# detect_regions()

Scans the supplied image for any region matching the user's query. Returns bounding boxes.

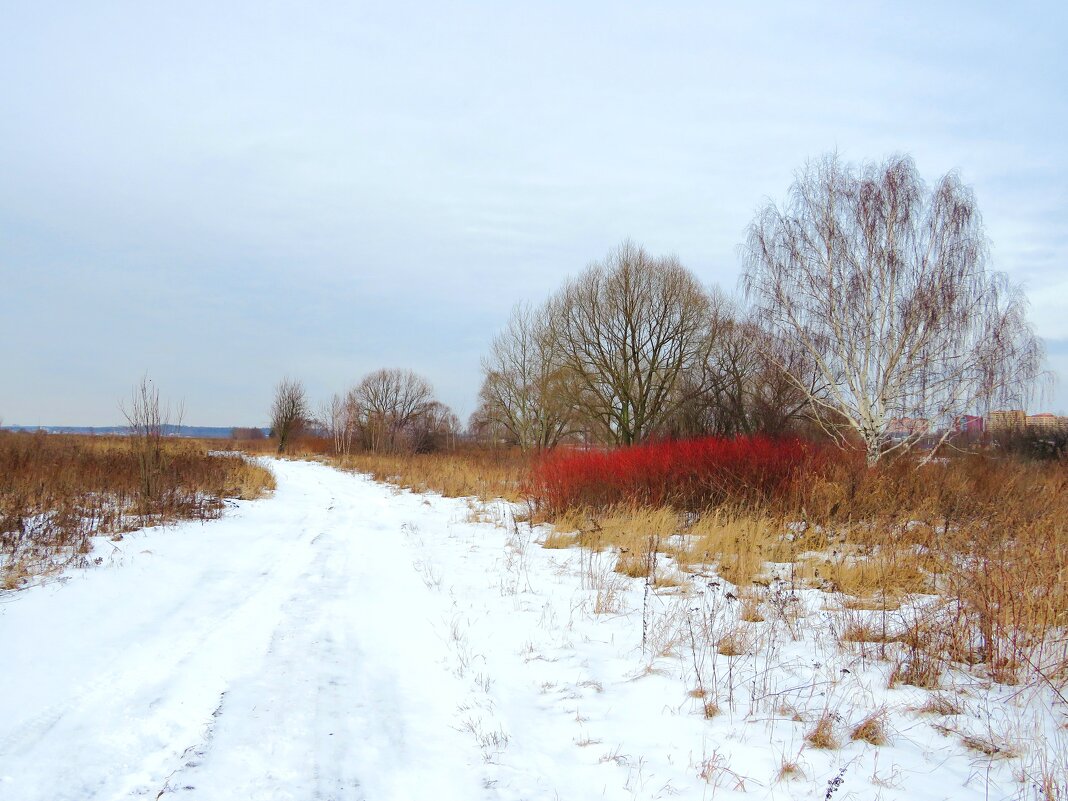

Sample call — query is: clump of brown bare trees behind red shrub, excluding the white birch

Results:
[470,241,815,450]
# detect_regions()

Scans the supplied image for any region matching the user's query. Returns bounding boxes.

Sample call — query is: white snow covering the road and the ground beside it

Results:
[0,461,1068,801]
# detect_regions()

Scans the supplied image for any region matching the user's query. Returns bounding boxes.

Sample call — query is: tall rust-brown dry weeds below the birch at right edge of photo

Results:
[811,457,1068,690]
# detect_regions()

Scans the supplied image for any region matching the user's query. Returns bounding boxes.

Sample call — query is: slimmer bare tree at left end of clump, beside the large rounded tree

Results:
[476,304,572,451]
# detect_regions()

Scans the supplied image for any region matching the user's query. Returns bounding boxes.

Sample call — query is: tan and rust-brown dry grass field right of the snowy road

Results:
[534,448,1068,693]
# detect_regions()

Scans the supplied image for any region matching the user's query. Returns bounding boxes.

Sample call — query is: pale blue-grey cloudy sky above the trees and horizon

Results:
[0,0,1068,425]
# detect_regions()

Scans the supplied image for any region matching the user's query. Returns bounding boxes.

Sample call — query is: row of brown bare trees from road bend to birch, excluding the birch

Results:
[271,241,811,455]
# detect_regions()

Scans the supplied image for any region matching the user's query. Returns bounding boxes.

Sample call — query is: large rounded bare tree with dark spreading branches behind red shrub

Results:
[551,241,720,444]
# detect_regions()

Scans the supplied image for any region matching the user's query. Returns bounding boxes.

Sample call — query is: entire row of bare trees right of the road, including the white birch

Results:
[272,154,1042,466]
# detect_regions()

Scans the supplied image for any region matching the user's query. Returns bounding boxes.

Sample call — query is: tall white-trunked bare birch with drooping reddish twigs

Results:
[743,155,1042,465]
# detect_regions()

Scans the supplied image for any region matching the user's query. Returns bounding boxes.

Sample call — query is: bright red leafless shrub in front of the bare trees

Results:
[530,436,827,514]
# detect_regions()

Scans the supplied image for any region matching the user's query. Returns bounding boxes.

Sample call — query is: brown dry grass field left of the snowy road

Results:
[0,431,274,590]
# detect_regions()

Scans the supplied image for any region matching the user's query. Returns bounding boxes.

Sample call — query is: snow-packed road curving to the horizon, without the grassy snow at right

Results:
[0,461,485,801]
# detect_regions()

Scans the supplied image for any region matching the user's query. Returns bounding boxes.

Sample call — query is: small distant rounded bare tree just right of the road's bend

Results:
[351,370,437,452]
